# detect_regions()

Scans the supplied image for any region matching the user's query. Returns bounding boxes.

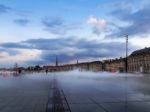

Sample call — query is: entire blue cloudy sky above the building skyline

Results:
[0,0,150,68]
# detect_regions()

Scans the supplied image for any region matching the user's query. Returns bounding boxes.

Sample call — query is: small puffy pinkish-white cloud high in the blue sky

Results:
[87,16,106,35]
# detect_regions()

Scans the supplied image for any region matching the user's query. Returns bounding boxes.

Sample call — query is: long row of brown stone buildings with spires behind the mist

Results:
[26,48,150,73]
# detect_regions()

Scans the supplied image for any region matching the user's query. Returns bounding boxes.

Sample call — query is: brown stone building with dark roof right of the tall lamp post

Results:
[128,48,150,73]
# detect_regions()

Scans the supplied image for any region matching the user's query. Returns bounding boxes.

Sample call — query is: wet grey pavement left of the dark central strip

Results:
[0,74,51,112]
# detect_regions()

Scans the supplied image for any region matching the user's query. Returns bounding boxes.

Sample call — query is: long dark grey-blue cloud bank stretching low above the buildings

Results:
[0,37,134,64]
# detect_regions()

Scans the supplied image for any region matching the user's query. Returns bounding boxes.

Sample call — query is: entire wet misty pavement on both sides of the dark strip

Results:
[0,71,150,112]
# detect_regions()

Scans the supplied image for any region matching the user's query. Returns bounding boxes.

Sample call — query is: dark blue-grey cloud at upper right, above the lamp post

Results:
[109,5,150,37]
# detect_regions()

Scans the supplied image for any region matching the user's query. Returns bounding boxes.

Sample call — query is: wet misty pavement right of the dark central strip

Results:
[56,71,150,112]
